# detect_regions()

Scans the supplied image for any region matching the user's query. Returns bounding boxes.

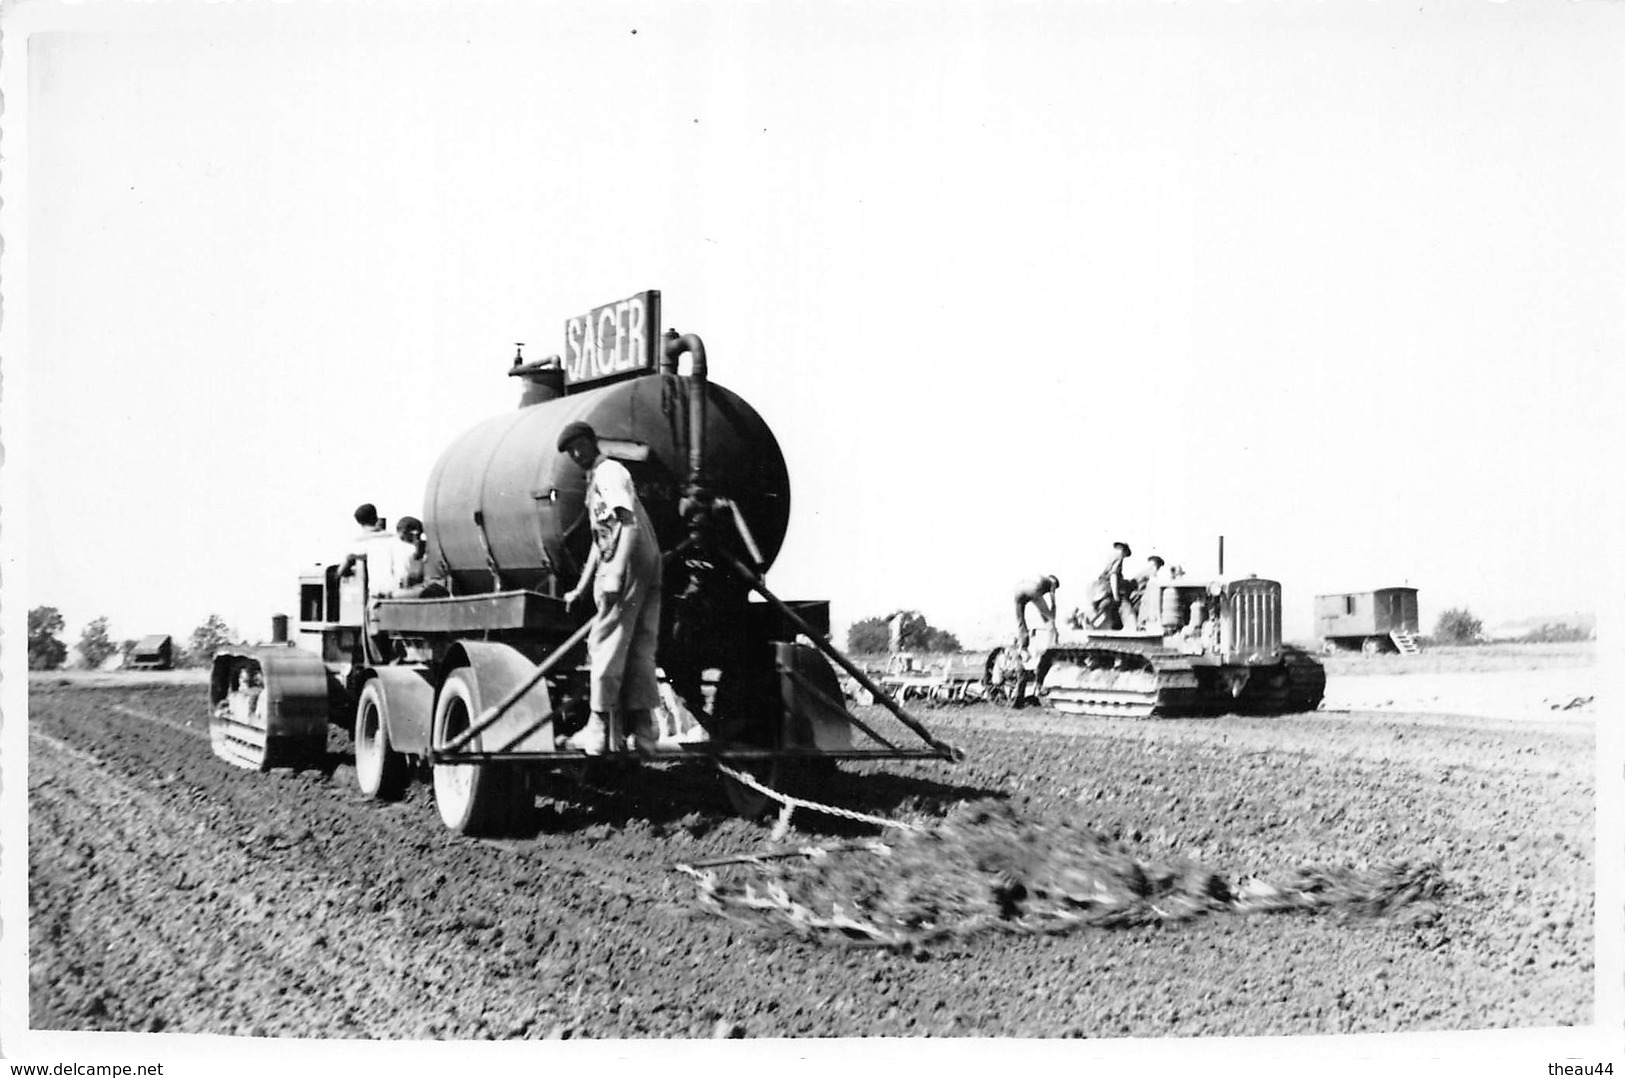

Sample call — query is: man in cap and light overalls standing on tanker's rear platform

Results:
[559,421,661,756]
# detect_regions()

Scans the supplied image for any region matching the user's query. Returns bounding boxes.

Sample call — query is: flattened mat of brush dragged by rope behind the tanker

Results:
[674,802,1450,951]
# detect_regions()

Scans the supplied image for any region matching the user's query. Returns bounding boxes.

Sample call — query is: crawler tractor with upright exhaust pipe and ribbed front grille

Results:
[985,538,1326,719]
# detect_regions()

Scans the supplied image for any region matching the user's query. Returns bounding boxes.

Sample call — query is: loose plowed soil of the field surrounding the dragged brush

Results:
[28,680,1594,1037]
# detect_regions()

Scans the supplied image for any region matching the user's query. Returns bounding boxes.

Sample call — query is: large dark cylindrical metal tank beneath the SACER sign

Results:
[423,374,790,595]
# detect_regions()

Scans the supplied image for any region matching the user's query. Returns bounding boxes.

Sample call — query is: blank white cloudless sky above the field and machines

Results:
[0,2,1625,644]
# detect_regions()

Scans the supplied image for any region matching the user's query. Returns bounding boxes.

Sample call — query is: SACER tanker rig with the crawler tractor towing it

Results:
[210,291,959,834]
